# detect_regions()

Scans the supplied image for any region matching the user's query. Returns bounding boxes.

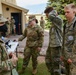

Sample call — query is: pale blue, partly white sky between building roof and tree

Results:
[16,0,48,14]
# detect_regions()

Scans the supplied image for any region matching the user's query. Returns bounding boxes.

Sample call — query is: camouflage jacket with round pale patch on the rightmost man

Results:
[64,17,76,59]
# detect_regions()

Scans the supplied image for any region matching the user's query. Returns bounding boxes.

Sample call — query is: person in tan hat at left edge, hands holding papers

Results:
[0,15,18,75]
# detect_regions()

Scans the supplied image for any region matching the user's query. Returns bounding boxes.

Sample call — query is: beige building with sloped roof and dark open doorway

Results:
[0,0,28,34]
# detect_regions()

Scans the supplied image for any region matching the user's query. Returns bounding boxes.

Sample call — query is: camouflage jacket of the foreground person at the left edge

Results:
[0,39,11,75]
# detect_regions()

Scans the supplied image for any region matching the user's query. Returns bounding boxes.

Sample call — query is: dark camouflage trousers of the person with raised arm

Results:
[45,46,61,75]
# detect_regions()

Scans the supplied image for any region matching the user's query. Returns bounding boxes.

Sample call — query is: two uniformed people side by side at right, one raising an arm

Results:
[44,4,76,75]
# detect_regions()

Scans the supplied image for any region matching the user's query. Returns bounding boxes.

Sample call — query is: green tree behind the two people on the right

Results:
[47,0,76,16]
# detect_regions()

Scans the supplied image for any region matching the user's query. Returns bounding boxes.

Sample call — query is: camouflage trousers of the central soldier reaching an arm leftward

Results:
[23,47,39,69]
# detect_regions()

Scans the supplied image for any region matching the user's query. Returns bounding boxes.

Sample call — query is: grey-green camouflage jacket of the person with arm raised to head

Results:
[49,11,63,47]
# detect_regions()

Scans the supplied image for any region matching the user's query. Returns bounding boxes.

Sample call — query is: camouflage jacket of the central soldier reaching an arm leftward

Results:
[19,25,44,47]
